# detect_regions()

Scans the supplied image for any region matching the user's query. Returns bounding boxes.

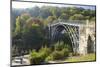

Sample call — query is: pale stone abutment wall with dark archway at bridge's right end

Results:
[79,21,95,55]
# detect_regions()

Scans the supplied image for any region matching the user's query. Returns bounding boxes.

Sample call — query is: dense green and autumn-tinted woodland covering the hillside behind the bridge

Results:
[11,6,95,55]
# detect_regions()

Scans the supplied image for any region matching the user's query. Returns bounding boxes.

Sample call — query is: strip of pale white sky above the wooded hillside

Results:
[12,1,95,10]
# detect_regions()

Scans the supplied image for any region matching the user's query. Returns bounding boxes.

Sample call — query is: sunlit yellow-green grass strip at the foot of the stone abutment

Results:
[65,53,96,62]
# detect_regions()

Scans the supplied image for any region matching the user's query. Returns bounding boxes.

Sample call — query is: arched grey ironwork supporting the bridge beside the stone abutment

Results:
[49,23,79,52]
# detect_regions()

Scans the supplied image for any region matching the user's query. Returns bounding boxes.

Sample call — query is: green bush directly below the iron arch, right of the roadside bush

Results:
[45,42,70,61]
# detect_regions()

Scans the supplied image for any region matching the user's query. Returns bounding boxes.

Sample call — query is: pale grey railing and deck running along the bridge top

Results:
[48,19,95,27]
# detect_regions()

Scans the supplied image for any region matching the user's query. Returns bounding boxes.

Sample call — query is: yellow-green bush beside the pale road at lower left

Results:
[30,46,51,64]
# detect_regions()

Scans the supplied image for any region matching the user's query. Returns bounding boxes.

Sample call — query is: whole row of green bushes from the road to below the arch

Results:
[30,42,70,64]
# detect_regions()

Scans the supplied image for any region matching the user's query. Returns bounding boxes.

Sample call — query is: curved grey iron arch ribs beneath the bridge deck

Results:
[48,24,79,53]
